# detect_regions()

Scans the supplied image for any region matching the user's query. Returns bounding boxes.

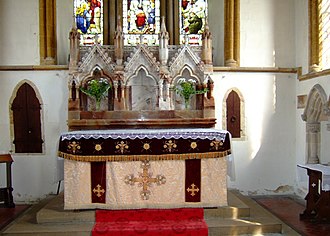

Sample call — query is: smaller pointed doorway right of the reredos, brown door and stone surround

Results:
[222,88,245,139]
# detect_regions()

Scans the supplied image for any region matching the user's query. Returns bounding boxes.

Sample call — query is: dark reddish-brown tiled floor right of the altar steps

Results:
[254,196,330,236]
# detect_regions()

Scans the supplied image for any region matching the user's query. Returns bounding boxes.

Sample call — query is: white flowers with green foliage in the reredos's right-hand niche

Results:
[174,78,208,109]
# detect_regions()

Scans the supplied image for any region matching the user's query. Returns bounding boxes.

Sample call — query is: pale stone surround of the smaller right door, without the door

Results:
[222,87,246,140]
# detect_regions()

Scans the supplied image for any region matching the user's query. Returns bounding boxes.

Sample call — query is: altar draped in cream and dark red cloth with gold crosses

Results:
[58,129,230,210]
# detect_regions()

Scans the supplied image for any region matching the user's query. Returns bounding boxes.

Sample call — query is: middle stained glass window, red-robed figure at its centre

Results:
[123,0,160,46]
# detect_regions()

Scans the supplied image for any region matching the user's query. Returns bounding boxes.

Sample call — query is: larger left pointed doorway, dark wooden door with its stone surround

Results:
[9,80,44,153]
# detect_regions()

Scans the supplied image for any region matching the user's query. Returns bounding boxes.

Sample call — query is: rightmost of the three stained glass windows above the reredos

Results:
[179,0,207,45]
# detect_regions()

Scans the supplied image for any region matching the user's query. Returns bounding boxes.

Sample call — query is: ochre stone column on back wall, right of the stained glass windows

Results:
[224,0,240,67]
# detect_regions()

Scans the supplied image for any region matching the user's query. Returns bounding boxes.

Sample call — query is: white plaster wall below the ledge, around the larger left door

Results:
[0,71,68,202]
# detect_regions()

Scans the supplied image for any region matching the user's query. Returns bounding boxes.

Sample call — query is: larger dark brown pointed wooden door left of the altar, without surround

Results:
[11,83,43,153]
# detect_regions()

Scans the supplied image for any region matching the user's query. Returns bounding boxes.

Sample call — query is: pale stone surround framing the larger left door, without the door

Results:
[9,79,45,154]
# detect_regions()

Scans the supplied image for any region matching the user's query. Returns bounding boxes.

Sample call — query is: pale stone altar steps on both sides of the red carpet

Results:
[2,191,298,236]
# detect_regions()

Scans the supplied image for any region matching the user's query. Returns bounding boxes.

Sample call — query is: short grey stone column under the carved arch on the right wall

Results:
[306,123,321,164]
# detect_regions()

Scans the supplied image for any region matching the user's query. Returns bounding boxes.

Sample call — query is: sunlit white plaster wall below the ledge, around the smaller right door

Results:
[212,72,296,194]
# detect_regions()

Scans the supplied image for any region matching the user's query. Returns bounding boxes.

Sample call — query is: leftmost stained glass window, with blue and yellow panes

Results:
[74,0,103,45]
